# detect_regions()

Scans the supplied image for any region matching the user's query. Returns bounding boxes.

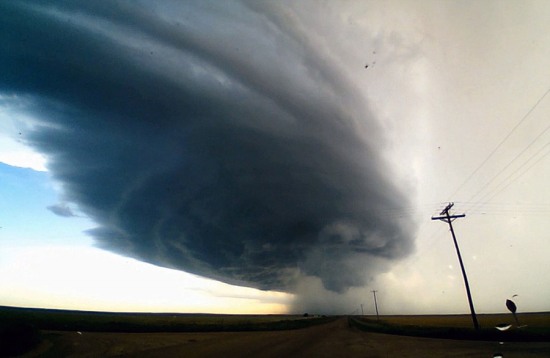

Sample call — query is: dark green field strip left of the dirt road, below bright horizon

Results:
[0,307,335,332]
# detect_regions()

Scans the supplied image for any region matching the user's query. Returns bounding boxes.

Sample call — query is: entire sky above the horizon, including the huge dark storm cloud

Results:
[0,1,550,314]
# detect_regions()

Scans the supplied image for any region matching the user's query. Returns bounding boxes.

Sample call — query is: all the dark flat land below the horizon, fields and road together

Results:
[4,308,550,358]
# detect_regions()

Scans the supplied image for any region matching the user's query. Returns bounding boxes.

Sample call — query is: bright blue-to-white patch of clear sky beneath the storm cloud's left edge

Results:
[0,162,289,313]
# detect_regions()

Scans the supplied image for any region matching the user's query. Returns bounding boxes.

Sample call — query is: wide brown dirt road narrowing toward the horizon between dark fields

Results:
[27,318,550,358]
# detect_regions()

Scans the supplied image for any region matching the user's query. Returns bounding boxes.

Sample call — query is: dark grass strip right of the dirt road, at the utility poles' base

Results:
[349,312,550,342]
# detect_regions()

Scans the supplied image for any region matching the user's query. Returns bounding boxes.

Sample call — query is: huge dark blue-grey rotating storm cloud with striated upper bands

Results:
[0,1,412,291]
